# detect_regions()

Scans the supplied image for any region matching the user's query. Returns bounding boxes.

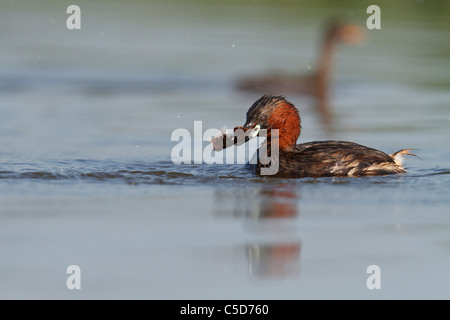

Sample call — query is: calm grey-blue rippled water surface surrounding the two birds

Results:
[0,1,450,299]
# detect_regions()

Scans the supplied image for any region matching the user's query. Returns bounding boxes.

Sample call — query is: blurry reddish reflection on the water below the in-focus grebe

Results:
[216,184,301,278]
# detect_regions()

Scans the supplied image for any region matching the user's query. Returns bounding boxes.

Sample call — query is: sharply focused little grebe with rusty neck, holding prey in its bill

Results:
[211,95,413,178]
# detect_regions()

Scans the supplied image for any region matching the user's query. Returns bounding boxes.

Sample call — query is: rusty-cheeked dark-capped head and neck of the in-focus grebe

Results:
[239,95,301,150]
